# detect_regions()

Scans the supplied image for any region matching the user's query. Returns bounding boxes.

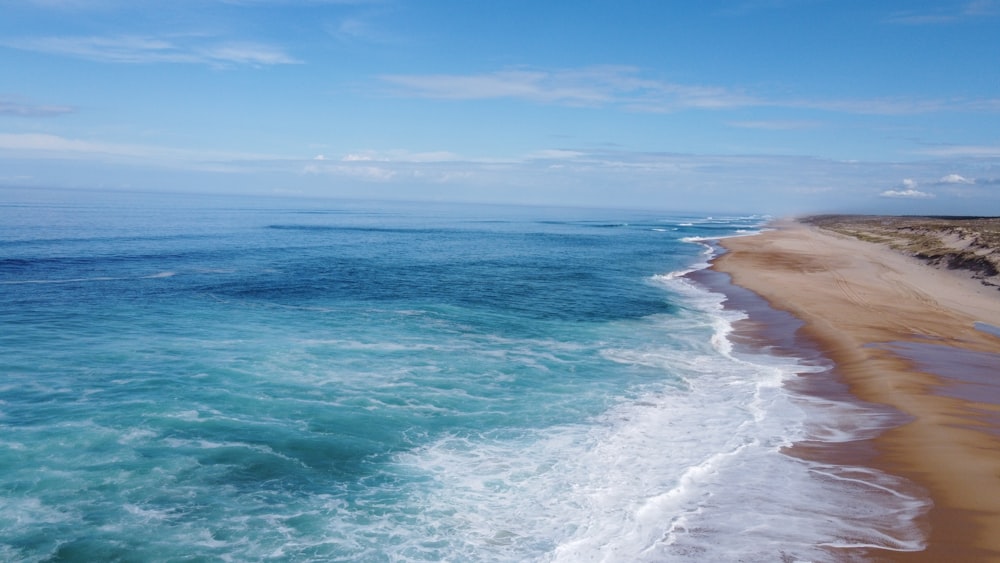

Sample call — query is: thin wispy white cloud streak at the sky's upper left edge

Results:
[0,35,299,66]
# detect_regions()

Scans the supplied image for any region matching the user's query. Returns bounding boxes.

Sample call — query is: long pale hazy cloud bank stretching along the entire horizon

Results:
[0,134,1000,215]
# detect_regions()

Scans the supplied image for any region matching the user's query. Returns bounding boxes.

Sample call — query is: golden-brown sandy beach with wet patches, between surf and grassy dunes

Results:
[713,221,1000,562]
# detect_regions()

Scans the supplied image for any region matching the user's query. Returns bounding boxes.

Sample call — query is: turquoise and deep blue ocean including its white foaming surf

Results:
[0,190,929,562]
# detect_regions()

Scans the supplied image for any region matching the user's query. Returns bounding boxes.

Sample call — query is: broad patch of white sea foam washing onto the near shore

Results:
[376,268,929,561]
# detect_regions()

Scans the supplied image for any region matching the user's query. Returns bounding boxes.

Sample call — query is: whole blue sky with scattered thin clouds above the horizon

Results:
[0,0,1000,215]
